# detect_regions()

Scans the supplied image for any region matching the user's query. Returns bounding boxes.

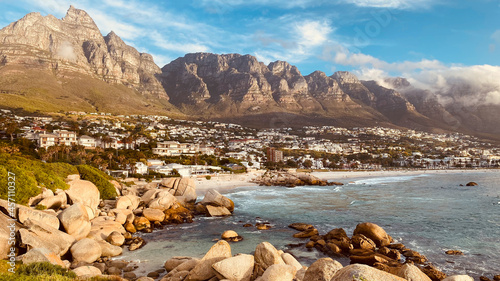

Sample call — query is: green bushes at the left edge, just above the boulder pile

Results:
[0,153,78,204]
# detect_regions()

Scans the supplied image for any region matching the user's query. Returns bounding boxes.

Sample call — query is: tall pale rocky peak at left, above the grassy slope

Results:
[0,6,168,99]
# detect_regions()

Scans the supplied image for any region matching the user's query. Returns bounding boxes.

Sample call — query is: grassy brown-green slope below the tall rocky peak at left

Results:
[0,65,184,117]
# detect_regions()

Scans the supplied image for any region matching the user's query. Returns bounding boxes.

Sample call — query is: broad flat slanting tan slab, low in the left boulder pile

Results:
[19,219,76,256]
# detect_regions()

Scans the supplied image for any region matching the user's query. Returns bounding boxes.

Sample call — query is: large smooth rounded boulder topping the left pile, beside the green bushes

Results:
[66,180,100,218]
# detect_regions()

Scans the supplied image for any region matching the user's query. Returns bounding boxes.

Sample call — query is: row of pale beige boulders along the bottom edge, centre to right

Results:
[156,237,480,281]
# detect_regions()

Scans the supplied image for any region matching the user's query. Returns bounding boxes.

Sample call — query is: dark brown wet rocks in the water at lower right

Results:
[289,222,488,281]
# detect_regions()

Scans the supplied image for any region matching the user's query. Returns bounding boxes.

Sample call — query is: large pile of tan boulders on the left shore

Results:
[0,175,234,280]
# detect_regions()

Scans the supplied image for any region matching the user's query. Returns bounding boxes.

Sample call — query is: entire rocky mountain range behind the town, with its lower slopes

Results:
[0,6,500,139]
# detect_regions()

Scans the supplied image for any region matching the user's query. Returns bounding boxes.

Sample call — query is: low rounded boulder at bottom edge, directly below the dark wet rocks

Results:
[331,264,407,281]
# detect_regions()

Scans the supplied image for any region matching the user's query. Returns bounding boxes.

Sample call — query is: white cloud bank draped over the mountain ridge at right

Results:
[323,45,500,106]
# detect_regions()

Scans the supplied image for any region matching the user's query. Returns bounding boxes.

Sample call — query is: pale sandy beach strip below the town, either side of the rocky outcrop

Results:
[195,170,500,192]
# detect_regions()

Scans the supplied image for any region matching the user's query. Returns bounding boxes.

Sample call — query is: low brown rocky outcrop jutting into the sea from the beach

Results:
[253,171,343,187]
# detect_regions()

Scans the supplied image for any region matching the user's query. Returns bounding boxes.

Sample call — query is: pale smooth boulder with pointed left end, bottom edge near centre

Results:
[212,254,254,281]
